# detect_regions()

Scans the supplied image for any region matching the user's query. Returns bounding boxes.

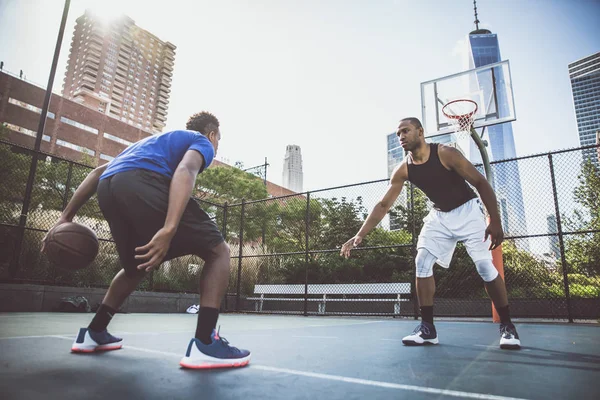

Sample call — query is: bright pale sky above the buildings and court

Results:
[0,0,600,190]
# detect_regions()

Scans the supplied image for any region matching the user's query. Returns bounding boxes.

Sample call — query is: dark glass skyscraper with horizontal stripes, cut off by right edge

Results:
[569,52,600,168]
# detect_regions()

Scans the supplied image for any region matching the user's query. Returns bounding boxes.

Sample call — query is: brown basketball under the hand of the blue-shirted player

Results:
[44,222,98,270]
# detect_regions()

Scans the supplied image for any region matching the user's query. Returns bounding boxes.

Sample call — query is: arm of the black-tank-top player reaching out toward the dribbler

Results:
[340,162,408,258]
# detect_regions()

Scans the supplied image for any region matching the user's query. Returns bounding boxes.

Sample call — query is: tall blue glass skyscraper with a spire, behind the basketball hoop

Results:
[468,8,529,244]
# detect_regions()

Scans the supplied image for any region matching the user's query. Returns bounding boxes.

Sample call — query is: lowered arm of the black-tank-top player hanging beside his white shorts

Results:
[439,146,504,250]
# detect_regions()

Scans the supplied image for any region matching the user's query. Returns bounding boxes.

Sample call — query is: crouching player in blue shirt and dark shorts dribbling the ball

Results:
[44,112,250,368]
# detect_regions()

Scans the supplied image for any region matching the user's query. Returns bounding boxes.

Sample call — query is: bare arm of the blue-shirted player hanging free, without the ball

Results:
[135,150,204,272]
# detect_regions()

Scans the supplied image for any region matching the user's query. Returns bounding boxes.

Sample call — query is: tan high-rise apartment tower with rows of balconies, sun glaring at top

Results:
[63,11,176,133]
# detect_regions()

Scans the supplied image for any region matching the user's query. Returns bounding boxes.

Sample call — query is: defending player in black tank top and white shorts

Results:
[341,118,520,349]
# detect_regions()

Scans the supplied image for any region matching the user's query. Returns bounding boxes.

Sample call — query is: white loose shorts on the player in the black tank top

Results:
[417,198,492,268]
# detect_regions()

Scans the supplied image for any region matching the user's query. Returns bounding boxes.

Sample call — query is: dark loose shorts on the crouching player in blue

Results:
[97,169,224,277]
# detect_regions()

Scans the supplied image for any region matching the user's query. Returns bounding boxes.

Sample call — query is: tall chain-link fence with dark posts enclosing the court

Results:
[0,142,600,320]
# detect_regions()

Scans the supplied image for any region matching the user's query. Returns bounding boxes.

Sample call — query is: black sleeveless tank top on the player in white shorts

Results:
[407,143,477,212]
